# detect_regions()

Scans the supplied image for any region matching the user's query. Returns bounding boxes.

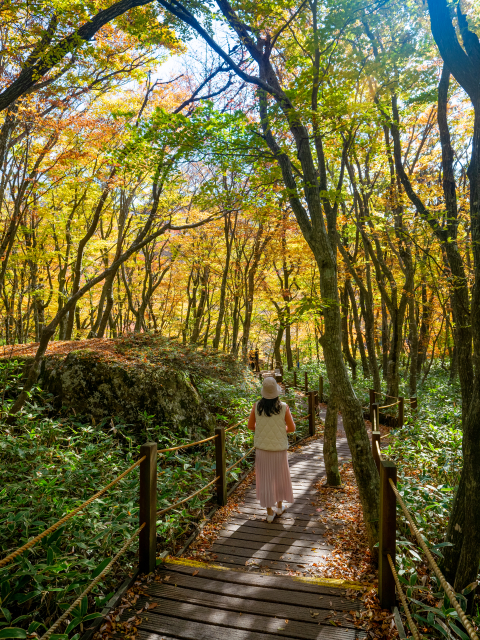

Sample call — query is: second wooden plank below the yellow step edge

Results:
[147,571,363,611]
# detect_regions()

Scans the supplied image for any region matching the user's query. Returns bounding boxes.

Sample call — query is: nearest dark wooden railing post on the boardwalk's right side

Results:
[378,460,397,609]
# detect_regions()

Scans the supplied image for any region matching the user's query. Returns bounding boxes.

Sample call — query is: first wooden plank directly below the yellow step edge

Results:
[161,563,352,597]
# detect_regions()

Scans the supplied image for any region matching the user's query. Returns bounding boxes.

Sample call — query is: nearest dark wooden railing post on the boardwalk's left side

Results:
[138,442,157,573]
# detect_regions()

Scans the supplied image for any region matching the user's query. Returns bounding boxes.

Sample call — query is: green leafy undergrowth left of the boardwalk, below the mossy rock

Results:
[0,361,258,640]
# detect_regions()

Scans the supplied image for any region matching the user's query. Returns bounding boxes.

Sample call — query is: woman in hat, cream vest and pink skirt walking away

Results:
[248,378,295,522]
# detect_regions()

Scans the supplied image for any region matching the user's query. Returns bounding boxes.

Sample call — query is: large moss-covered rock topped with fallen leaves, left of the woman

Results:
[1,334,243,438]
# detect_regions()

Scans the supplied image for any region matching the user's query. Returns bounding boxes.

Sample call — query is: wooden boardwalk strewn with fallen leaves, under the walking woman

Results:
[122,410,366,640]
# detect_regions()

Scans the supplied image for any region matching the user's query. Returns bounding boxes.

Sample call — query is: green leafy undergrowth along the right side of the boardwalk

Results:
[285,362,480,640]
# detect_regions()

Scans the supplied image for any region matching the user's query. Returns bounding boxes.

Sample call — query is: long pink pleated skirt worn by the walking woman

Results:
[255,449,294,507]
